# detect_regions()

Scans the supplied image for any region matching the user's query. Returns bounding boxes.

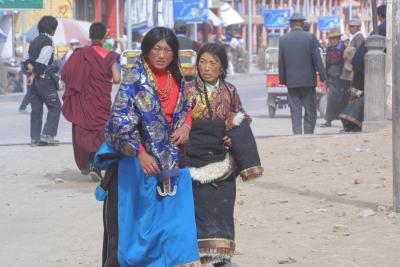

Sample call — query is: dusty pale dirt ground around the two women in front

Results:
[0,122,400,267]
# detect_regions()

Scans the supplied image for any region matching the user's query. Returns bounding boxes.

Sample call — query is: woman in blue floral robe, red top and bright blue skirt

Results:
[96,27,201,267]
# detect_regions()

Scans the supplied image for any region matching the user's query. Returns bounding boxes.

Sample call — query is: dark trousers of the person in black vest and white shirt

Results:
[30,75,61,141]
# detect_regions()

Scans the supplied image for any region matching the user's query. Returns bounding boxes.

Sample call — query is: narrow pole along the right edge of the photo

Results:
[392,1,400,213]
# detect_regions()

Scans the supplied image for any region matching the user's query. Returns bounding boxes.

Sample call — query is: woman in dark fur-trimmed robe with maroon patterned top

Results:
[185,43,263,267]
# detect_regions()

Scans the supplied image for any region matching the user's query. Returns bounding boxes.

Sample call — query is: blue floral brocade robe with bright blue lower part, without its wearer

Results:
[95,57,200,267]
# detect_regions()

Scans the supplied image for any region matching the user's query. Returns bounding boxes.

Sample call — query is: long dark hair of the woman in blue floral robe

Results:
[141,27,183,83]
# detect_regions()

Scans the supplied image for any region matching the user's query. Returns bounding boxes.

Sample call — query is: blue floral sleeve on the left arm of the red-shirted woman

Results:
[105,84,141,156]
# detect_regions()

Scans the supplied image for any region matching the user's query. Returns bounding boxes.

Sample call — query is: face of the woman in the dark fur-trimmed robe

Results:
[199,52,222,84]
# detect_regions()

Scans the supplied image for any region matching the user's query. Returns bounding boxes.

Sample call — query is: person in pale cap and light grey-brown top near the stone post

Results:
[341,19,365,81]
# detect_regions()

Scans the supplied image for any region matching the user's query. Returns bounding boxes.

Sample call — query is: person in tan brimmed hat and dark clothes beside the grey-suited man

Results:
[321,28,350,127]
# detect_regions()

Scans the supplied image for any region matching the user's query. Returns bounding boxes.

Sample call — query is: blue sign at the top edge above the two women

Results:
[174,0,208,23]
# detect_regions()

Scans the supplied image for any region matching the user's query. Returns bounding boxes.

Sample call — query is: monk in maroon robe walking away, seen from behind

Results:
[61,22,120,181]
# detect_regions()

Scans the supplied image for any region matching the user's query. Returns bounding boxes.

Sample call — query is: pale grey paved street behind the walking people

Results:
[0,72,341,145]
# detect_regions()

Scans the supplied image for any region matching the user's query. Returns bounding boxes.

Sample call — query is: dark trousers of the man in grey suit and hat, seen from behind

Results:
[288,87,317,134]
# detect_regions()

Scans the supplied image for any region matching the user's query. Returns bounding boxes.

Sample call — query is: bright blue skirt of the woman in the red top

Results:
[96,144,200,267]
